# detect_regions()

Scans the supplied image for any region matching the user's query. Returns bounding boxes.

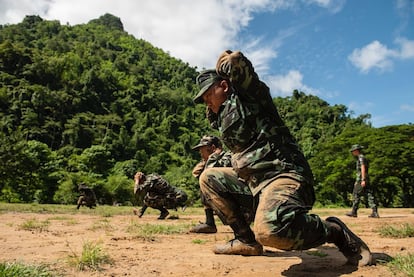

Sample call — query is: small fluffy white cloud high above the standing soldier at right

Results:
[348,38,414,73]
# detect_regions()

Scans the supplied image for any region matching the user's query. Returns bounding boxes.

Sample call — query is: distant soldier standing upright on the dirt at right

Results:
[346,144,379,218]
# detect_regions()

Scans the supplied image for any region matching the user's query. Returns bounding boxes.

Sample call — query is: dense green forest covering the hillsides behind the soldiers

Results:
[0,14,414,207]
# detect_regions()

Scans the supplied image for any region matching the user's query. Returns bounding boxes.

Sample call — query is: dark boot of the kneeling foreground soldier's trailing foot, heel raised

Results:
[326,217,374,266]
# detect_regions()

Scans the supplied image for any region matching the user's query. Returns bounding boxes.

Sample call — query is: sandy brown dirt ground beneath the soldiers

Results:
[0,207,414,277]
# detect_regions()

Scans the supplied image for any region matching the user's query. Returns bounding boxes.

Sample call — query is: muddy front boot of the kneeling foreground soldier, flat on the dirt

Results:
[214,218,263,256]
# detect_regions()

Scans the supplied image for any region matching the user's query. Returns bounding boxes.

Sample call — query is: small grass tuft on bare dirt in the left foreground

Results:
[68,241,112,271]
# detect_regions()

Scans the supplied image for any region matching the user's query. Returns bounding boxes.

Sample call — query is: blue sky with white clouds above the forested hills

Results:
[0,0,414,127]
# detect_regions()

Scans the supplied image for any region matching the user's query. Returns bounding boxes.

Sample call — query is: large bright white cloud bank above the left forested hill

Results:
[0,0,276,68]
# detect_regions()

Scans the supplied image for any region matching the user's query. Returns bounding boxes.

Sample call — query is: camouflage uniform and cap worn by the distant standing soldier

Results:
[351,145,378,217]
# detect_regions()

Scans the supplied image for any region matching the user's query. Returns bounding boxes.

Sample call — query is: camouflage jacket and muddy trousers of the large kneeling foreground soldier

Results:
[194,52,328,250]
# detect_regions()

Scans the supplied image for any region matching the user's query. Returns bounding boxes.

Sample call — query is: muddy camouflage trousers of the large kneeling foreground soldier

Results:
[200,168,328,250]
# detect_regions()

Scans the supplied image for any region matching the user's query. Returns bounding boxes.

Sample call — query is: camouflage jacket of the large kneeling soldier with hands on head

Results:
[209,52,313,195]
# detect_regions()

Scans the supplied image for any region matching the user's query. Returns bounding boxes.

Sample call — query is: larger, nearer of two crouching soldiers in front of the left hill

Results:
[134,172,188,219]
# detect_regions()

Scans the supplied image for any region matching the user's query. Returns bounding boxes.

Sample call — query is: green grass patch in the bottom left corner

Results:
[0,262,58,277]
